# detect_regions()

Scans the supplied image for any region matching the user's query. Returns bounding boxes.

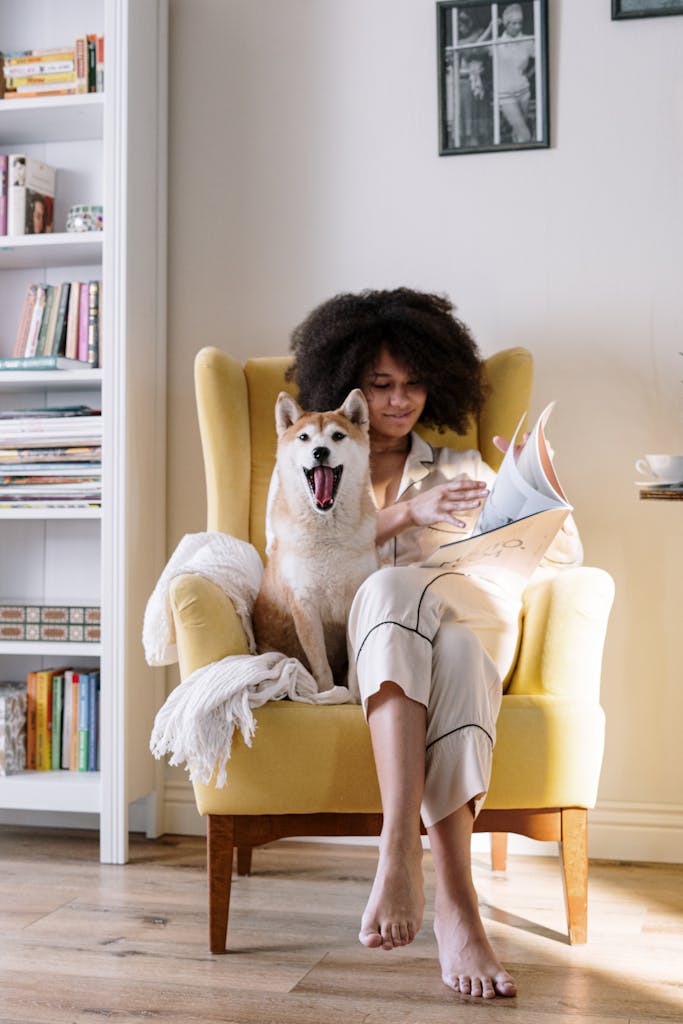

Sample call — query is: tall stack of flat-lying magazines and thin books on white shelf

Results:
[0,406,102,509]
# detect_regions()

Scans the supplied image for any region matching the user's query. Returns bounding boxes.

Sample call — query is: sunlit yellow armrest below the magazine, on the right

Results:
[507,567,614,703]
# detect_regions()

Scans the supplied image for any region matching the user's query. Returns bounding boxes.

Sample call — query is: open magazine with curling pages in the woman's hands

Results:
[422,402,572,582]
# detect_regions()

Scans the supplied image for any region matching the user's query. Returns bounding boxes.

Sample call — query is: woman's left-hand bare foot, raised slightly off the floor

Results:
[358,838,425,949]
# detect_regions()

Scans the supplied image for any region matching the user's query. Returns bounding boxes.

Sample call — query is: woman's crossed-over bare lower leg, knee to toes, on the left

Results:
[358,681,426,949]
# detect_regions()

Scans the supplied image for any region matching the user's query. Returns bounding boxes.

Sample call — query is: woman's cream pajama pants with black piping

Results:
[348,566,520,826]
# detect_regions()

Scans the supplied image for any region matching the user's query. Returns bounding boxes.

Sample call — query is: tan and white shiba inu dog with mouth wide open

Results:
[253,388,378,690]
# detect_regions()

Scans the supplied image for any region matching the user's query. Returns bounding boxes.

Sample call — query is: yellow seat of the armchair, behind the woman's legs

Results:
[194,695,604,815]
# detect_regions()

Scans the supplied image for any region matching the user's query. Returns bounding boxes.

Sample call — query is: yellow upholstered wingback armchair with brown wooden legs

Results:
[170,348,613,952]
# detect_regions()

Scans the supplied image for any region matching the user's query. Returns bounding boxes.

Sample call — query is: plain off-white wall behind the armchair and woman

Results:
[167,0,683,860]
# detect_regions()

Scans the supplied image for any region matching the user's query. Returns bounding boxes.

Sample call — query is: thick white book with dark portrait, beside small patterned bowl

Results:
[7,153,56,234]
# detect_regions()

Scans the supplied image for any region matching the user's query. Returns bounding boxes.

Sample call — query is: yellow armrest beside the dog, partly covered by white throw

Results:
[169,573,249,679]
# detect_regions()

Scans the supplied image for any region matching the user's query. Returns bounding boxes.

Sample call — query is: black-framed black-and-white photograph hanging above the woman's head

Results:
[436,0,550,156]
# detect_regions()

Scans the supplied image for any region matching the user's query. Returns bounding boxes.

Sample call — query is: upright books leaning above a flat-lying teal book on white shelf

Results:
[0,281,102,370]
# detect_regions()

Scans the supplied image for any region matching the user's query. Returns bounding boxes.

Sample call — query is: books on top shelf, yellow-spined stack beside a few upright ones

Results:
[0,33,104,99]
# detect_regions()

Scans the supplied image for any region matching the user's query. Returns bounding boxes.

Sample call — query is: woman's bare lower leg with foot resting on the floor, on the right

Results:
[427,804,517,999]
